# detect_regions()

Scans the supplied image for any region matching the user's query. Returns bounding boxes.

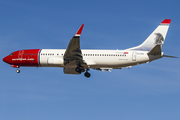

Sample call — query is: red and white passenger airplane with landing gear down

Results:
[3,19,177,78]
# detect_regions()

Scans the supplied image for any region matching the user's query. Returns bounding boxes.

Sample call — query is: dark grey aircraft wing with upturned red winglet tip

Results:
[64,24,84,65]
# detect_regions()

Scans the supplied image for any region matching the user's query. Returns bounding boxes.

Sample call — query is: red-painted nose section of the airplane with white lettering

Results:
[3,49,40,67]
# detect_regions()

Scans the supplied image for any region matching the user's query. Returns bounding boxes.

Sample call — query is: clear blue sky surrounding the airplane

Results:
[0,0,180,120]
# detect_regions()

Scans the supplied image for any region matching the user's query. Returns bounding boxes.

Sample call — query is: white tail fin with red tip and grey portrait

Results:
[128,19,171,51]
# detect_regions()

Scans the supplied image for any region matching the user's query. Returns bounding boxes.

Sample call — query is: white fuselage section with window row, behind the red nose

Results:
[39,49,161,69]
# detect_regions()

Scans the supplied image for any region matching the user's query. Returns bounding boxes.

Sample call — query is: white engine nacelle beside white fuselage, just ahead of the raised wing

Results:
[48,57,64,65]
